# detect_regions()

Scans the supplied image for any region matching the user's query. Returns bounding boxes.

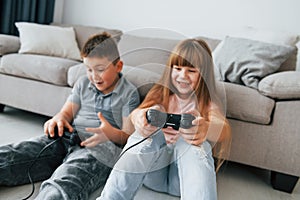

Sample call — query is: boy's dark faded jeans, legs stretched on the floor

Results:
[0,136,115,200]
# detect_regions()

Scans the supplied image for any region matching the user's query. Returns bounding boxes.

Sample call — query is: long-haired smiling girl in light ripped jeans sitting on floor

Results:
[98,39,231,200]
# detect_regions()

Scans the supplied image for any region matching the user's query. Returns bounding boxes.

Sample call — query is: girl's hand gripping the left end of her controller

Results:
[131,105,162,137]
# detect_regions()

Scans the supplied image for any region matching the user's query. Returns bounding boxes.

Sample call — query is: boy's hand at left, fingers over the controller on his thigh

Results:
[44,115,73,137]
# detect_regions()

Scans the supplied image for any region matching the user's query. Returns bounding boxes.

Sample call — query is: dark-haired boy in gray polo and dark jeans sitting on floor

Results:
[0,33,139,200]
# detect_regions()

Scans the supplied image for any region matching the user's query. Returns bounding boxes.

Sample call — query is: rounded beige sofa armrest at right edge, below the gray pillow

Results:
[258,71,300,100]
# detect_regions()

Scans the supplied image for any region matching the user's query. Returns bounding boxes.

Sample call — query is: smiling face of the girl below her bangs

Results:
[171,65,200,98]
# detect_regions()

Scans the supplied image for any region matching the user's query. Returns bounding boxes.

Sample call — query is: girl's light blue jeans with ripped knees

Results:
[97,131,217,200]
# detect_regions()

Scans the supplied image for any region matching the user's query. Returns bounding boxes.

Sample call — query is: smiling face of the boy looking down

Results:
[83,57,123,94]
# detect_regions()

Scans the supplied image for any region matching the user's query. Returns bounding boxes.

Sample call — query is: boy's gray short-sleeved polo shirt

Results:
[68,74,140,132]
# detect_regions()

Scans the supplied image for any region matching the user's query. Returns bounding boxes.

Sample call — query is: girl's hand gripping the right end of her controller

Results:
[179,110,209,146]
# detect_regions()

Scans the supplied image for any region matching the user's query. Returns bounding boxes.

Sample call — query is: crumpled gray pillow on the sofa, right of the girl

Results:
[213,37,295,89]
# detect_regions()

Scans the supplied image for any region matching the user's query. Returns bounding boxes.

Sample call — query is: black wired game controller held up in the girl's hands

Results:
[146,109,195,130]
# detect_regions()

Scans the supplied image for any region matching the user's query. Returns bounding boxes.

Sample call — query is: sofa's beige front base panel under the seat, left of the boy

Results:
[0,73,72,116]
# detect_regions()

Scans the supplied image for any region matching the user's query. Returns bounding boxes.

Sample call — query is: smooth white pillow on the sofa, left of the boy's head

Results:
[15,22,81,60]
